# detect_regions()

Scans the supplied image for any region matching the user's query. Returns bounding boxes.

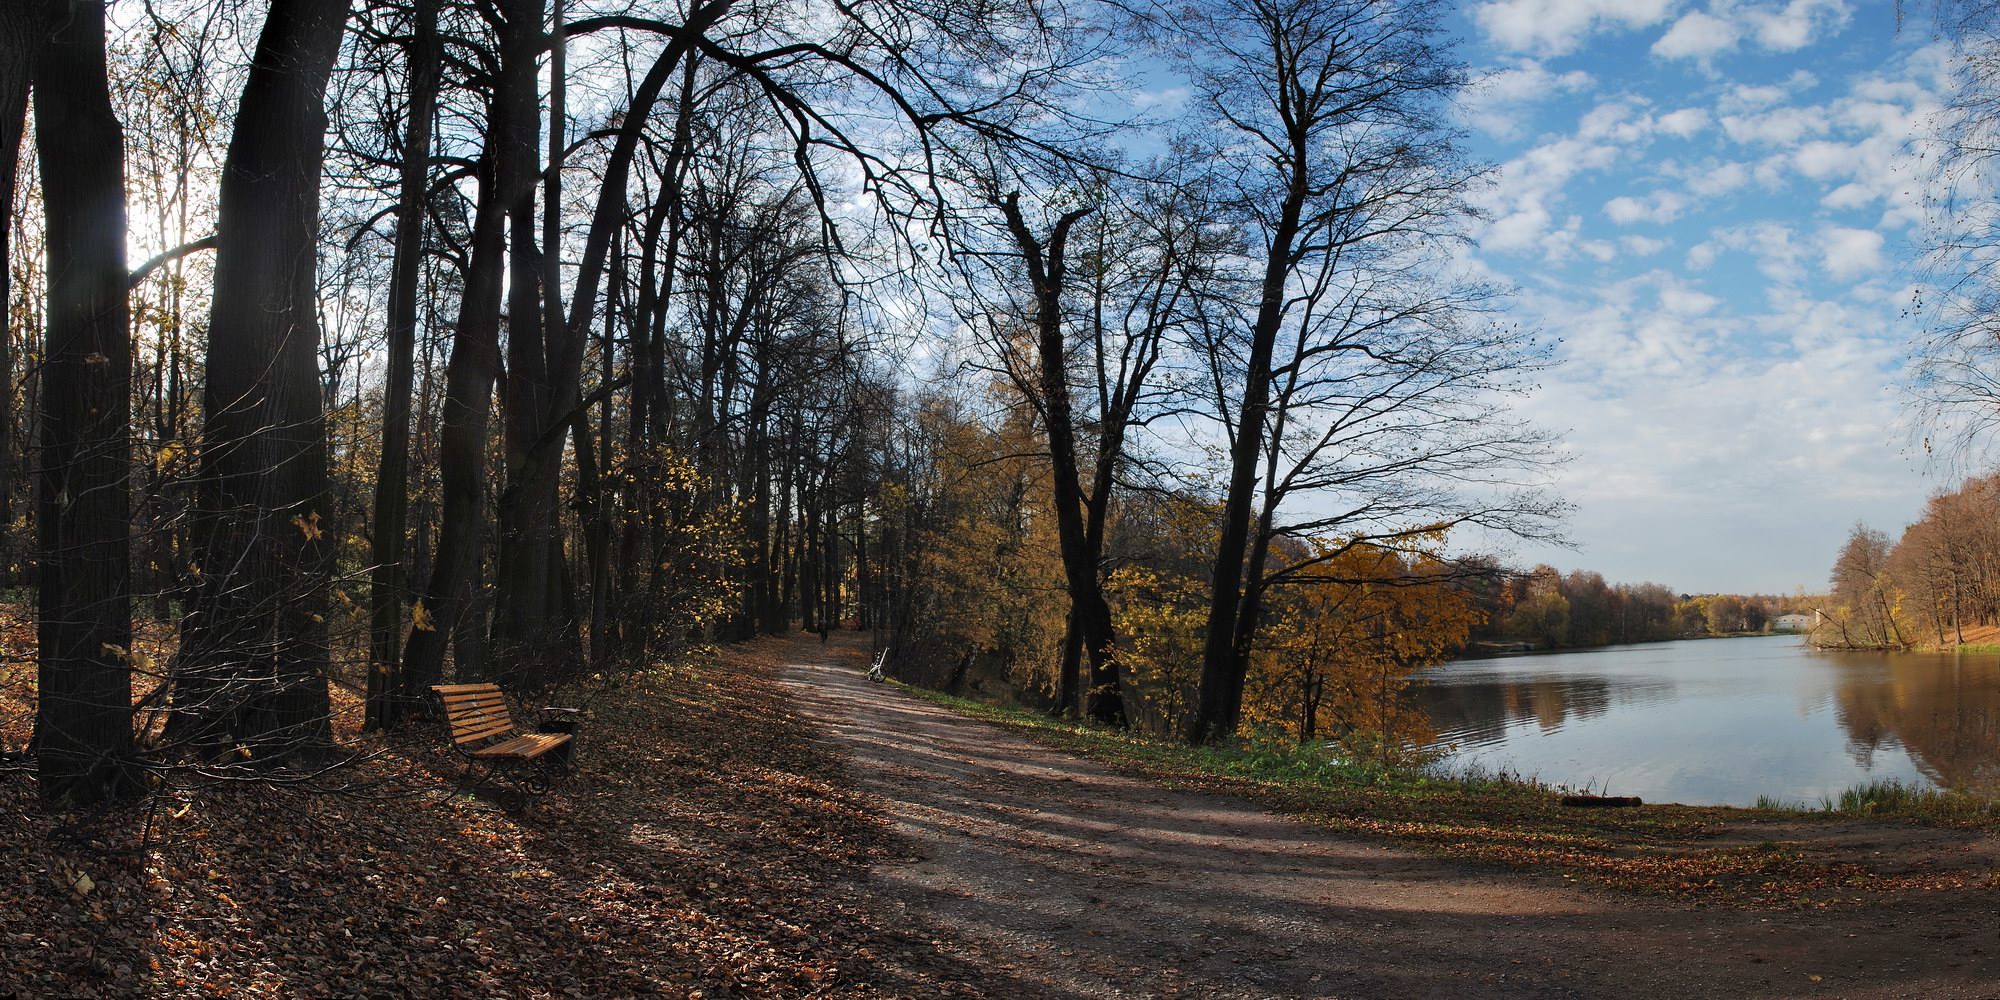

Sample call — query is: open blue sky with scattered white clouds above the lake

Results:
[1450,0,1964,592]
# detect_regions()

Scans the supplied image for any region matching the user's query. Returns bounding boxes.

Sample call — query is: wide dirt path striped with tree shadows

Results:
[784,644,2000,998]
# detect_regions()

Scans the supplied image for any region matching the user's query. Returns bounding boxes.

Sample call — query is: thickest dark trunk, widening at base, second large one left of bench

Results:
[174,0,348,752]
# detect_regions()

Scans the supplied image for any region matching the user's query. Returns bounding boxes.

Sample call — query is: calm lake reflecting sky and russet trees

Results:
[1414,636,2000,806]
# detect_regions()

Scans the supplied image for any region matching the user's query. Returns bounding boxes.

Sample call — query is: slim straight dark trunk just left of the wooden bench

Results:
[364,0,442,730]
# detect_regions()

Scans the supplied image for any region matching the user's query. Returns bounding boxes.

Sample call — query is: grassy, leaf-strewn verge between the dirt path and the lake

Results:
[896,684,2000,908]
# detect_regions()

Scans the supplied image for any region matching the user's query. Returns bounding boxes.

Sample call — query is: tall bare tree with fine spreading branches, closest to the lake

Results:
[1186,0,1552,742]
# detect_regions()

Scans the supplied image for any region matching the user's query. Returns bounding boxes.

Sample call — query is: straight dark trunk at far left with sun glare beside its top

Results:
[31,0,138,802]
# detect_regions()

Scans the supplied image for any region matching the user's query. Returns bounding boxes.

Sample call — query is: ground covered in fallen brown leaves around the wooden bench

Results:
[0,640,984,998]
